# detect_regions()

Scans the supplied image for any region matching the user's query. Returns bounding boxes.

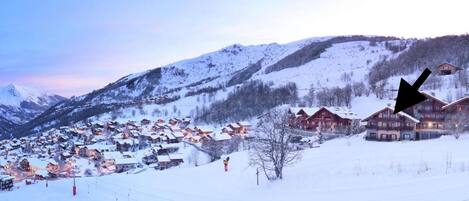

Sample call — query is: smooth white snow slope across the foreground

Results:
[0,133,469,201]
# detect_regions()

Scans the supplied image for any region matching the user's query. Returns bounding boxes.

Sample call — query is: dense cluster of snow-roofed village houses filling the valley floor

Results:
[0,118,250,186]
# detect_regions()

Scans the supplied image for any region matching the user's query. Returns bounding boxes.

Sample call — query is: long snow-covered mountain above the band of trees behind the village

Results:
[8,36,469,136]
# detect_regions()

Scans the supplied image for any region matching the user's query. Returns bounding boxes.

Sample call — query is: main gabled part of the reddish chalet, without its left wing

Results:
[306,107,358,133]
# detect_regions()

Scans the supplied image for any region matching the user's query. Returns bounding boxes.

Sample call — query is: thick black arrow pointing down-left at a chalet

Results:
[394,68,432,114]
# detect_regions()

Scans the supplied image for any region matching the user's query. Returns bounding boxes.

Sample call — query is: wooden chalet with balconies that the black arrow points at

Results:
[362,107,420,141]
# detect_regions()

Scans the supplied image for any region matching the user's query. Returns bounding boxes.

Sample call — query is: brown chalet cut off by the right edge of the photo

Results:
[442,96,469,131]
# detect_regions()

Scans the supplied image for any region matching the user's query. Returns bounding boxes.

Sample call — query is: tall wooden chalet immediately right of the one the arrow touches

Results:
[404,92,448,140]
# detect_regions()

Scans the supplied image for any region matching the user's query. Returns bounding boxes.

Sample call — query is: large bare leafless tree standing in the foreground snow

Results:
[250,109,301,180]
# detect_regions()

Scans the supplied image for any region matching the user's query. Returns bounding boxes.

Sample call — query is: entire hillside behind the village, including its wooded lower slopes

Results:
[8,36,467,137]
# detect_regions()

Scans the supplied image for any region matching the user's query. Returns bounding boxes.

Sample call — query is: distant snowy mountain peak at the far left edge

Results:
[0,84,65,137]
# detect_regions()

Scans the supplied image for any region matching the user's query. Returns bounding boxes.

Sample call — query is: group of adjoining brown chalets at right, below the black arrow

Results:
[362,93,469,141]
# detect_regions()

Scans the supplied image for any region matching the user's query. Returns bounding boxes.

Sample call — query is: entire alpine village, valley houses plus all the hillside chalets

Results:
[0,63,469,190]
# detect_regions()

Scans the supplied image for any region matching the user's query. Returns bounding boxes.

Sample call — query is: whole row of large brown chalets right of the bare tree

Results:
[288,93,469,141]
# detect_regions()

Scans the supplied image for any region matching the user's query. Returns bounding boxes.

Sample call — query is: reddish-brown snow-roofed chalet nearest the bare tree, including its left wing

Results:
[289,107,358,132]
